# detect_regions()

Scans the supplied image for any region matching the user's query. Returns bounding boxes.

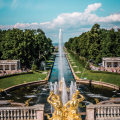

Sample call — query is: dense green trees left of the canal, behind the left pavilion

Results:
[0,29,53,65]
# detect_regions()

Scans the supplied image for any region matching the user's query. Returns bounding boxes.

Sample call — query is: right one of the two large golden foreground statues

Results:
[64,90,85,120]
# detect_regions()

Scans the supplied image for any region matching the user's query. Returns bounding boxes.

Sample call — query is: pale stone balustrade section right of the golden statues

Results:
[86,103,120,120]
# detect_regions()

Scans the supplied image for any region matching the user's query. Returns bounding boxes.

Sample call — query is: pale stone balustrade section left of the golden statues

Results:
[0,104,44,120]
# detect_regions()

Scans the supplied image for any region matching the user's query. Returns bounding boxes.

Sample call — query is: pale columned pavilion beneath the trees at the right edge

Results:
[102,57,120,68]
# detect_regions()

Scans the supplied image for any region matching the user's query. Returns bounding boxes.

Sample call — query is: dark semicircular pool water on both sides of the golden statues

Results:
[1,80,117,113]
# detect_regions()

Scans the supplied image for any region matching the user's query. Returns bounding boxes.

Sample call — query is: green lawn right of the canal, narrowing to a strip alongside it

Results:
[67,51,120,86]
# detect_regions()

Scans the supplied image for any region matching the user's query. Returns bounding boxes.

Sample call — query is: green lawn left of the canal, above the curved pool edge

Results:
[0,72,46,89]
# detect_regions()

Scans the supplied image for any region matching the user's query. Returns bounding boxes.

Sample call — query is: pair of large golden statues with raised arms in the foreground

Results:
[47,90,85,120]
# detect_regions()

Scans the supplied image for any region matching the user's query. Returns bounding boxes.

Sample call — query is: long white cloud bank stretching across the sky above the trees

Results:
[0,0,120,31]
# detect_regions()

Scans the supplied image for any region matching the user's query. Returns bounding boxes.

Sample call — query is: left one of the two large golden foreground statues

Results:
[47,91,63,120]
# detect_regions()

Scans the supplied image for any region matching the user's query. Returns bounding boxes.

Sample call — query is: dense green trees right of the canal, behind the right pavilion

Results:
[65,23,120,63]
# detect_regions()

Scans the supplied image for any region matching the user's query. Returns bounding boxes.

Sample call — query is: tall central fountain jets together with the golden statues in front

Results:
[47,29,85,120]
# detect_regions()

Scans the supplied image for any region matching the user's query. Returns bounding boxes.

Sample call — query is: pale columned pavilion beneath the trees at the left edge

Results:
[0,60,20,70]
